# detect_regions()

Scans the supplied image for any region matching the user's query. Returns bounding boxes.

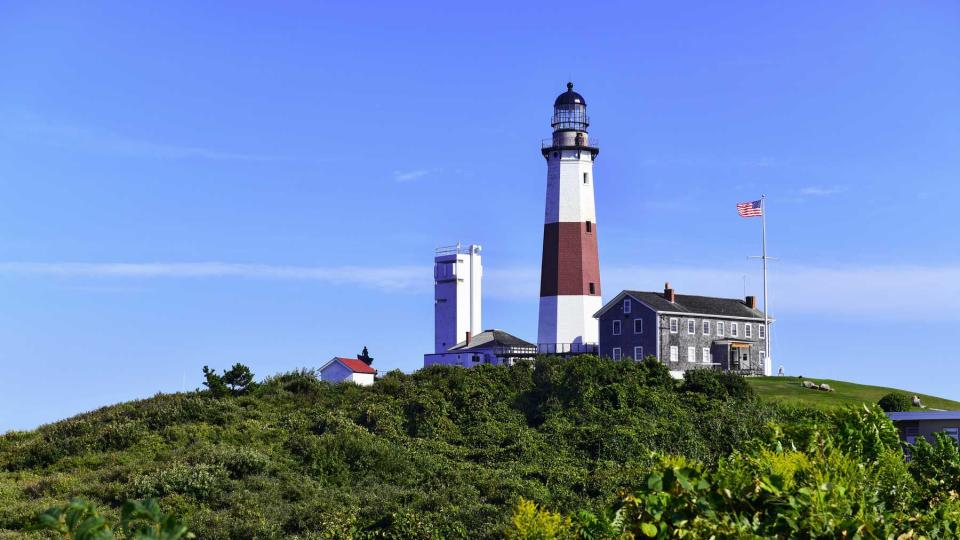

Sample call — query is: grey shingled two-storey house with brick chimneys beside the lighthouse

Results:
[594,283,773,378]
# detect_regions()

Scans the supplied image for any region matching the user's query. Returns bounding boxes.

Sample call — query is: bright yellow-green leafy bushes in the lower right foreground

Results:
[511,407,960,539]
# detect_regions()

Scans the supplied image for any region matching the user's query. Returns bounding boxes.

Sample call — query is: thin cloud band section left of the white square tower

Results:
[0,262,432,291]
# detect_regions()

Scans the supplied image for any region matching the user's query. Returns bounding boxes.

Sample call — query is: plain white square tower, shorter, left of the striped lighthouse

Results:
[433,244,483,354]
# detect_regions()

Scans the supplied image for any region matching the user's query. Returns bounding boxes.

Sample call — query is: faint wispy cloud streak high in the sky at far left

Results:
[0,109,289,161]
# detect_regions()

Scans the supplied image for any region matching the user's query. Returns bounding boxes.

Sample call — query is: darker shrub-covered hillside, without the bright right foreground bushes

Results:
[0,357,806,540]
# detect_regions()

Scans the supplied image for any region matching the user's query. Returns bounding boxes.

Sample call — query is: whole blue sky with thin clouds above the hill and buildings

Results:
[0,1,960,431]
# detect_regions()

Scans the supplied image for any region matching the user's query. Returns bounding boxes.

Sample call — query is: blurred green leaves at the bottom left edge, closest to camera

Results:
[29,499,194,540]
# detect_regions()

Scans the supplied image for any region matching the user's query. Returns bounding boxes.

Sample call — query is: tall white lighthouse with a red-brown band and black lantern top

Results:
[537,83,602,354]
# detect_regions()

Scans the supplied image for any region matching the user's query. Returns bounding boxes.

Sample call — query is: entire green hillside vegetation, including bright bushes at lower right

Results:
[0,356,960,539]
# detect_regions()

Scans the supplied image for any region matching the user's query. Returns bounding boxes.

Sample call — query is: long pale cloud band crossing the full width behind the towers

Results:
[0,262,960,321]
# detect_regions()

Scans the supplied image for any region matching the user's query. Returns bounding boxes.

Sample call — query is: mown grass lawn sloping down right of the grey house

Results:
[747,377,960,411]
